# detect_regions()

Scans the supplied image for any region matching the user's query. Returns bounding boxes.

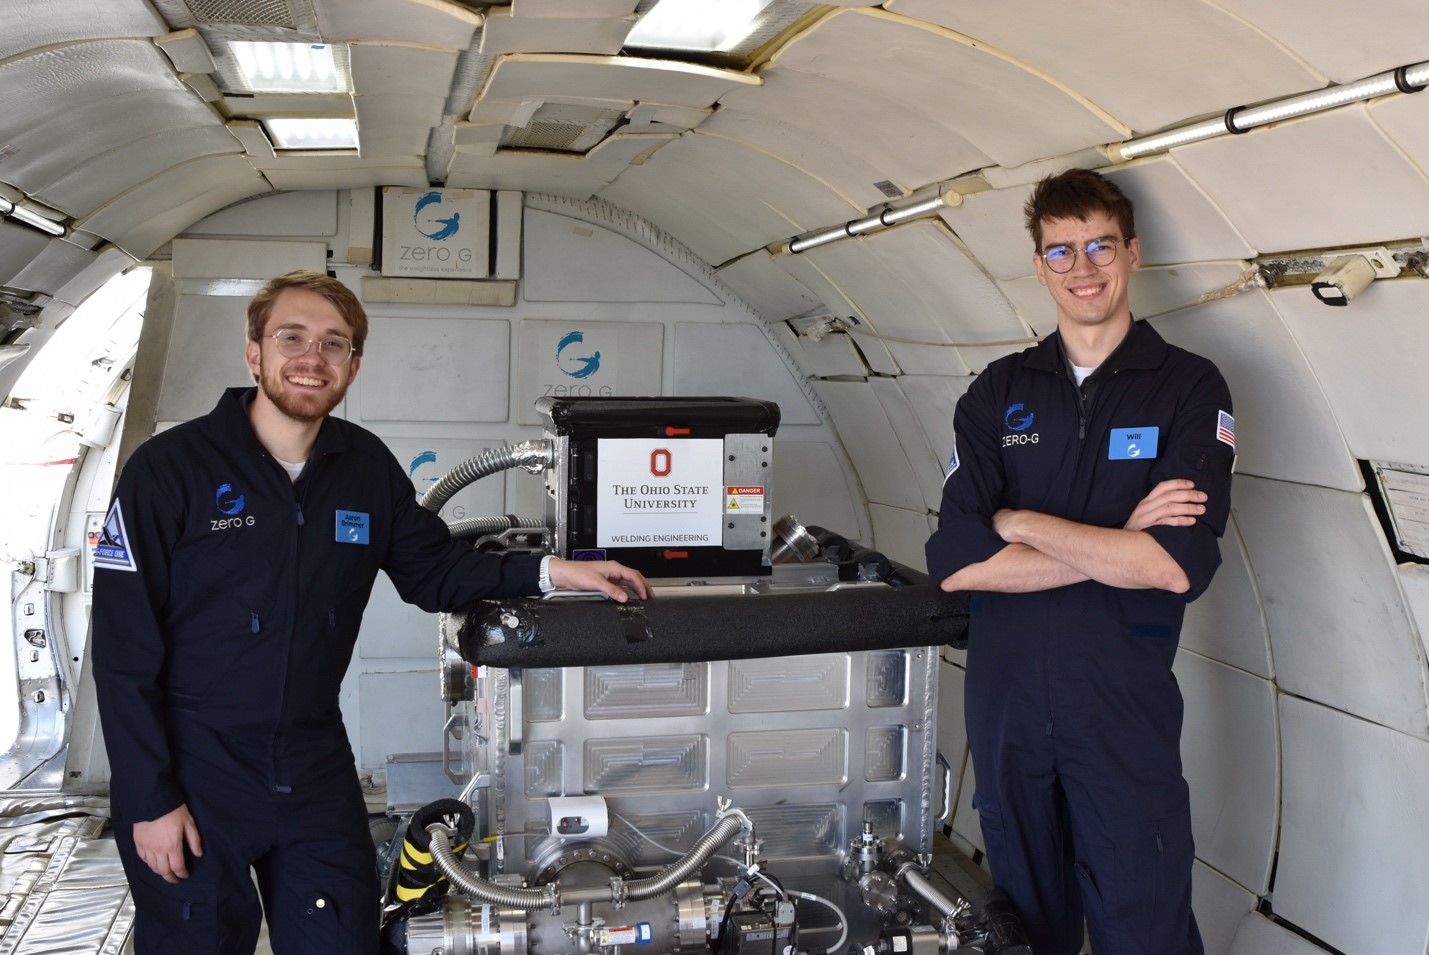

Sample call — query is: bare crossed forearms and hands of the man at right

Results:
[940,479,1206,593]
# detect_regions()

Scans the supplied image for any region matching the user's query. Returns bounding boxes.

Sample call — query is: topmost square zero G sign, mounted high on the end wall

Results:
[382,186,492,279]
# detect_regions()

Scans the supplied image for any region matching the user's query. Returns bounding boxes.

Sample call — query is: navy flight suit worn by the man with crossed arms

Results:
[927,323,1235,955]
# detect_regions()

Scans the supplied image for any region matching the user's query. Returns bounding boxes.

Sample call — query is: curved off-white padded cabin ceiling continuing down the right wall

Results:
[0,0,1429,955]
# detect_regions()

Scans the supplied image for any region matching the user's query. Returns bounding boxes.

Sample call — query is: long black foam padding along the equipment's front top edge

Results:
[452,586,967,668]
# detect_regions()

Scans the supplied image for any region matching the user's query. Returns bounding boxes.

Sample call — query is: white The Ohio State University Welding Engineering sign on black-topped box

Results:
[596,437,725,548]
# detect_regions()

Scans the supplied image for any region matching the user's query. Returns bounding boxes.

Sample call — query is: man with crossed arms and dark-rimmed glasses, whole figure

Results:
[927,169,1235,955]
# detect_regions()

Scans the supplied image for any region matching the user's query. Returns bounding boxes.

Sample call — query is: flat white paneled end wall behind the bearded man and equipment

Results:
[134,190,863,773]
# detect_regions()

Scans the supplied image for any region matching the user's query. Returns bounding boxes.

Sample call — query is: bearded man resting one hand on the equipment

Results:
[93,272,649,955]
